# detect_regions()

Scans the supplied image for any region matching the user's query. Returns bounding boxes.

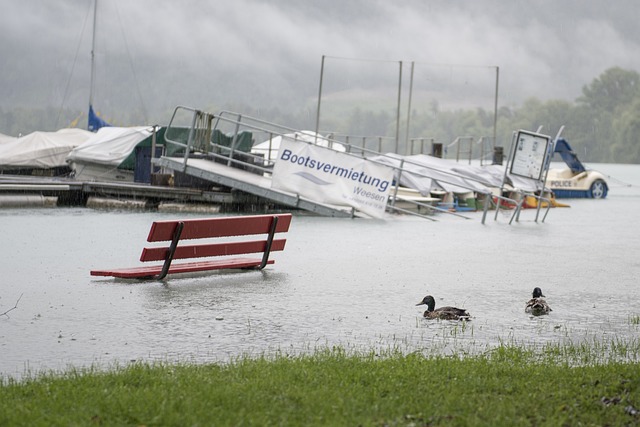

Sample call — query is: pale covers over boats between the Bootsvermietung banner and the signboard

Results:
[369,153,541,197]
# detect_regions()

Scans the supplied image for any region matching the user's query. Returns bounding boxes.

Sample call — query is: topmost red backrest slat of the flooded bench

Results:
[147,214,291,242]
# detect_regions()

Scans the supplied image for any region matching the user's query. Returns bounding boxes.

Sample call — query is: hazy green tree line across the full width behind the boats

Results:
[0,67,640,163]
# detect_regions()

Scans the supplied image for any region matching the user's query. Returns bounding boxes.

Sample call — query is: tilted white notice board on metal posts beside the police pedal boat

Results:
[510,130,550,180]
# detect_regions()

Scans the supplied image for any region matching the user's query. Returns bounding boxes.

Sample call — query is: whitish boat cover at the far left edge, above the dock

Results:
[0,129,93,170]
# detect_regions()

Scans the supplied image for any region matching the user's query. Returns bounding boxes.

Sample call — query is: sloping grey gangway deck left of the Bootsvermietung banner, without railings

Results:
[154,156,360,218]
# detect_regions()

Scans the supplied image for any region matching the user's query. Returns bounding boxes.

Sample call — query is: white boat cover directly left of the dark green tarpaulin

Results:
[67,126,153,167]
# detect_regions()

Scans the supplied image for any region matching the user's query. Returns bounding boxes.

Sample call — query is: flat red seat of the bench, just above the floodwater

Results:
[91,258,274,279]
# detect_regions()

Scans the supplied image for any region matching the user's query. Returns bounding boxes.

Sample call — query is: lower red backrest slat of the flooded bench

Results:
[140,239,286,262]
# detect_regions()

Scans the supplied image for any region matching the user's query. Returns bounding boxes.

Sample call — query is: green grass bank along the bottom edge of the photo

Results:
[0,342,640,426]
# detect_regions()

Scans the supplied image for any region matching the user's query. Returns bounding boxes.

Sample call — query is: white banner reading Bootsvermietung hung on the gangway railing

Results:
[271,139,393,218]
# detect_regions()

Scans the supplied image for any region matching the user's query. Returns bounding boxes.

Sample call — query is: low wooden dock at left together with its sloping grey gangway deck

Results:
[0,153,354,217]
